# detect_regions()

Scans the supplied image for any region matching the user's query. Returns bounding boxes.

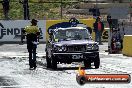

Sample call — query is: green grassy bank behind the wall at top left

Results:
[0,0,78,20]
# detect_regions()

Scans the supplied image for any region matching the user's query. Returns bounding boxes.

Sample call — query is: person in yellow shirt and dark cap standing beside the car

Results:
[22,19,40,70]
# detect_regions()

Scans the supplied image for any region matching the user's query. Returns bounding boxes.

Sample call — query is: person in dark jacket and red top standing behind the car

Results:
[94,17,104,44]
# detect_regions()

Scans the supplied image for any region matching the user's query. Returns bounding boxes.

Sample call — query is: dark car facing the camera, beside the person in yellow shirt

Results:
[46,27,100,69]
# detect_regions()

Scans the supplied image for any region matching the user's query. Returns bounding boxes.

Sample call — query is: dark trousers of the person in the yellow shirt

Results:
[27,45,36,68]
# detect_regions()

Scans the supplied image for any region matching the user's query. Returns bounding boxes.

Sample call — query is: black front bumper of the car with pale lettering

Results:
[53,51,99,62]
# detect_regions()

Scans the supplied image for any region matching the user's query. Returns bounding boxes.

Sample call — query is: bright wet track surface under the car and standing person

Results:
[0,44,132,88]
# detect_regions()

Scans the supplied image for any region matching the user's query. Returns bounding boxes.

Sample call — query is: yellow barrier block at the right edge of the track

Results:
[122,35,132,56]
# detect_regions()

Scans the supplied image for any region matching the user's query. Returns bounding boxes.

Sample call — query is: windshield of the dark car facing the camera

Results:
[54,29,90,41]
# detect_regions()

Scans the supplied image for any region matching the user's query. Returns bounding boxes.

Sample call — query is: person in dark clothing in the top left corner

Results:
[0,0,9,20]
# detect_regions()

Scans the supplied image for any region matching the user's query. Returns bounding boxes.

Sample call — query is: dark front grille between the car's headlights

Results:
[67,45,86,52]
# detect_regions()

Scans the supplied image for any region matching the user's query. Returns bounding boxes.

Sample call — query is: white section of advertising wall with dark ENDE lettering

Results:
[0,20,46,43]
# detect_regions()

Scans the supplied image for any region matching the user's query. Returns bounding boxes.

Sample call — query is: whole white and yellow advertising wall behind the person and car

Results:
[0,19,113,43]
